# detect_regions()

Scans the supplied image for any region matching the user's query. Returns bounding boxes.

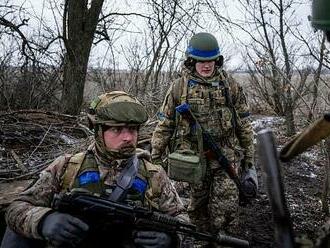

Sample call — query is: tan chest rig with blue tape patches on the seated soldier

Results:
[62,151,150,206]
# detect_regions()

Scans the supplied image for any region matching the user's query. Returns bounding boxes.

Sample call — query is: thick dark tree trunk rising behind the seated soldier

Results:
[61,0,104,114]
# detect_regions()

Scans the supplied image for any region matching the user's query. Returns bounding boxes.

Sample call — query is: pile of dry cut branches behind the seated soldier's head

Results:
[0,110,157,183]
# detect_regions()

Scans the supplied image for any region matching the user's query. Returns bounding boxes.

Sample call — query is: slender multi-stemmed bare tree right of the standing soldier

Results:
[208,0,311,135]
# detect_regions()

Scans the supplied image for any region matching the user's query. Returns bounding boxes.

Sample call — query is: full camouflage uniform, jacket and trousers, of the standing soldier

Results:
[152,67,254,246]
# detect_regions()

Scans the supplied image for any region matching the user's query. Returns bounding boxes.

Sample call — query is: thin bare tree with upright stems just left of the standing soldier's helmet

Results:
[142,0,201,92]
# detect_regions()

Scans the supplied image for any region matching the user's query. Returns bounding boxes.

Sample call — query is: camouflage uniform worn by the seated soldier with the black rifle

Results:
[5,91,189,247]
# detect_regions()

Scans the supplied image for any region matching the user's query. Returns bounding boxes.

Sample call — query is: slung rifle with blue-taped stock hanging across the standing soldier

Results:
[175,103,253,205]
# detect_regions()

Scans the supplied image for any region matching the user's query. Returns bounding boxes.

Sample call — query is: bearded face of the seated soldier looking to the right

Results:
[103,126,138,150]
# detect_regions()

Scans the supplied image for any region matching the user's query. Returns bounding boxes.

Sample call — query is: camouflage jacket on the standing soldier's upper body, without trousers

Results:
[151,69,254,169]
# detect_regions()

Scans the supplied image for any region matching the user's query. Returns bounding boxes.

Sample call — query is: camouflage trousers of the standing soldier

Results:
[188,161,238,248]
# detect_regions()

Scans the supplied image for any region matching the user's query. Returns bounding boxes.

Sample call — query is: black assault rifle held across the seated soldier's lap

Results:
[52,191,249,247]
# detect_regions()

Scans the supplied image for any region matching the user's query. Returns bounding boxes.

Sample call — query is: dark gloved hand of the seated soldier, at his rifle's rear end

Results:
[40,212,89,246]
